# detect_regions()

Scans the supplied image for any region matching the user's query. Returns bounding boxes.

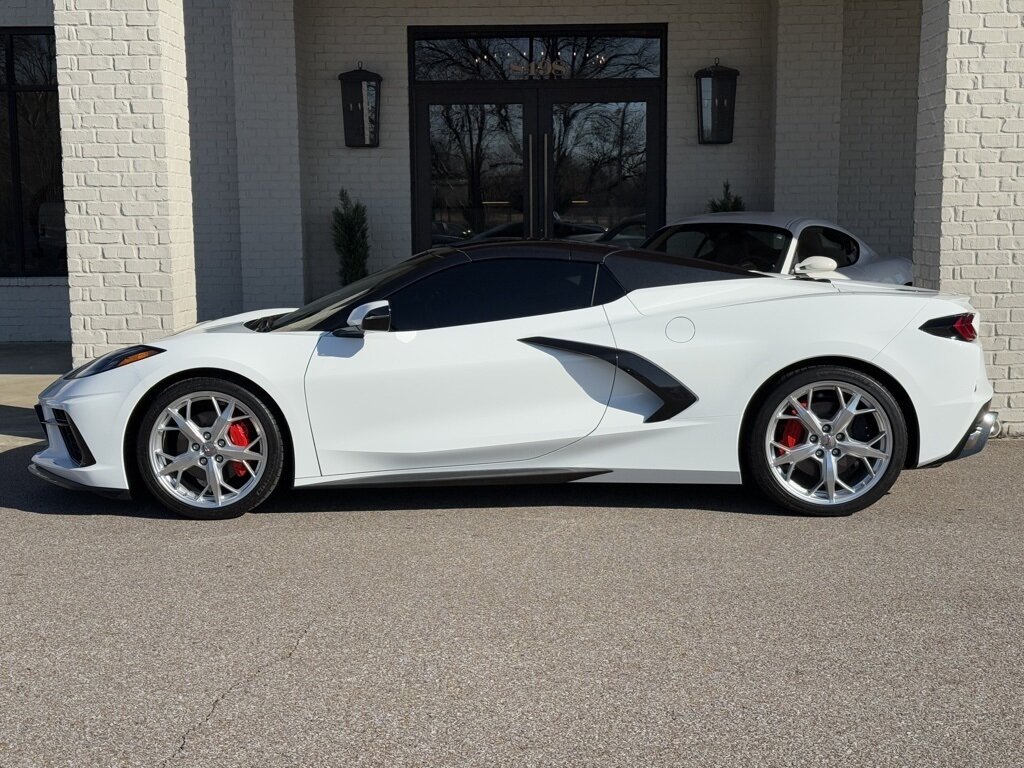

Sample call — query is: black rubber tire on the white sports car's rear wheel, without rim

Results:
[741,366,908,517]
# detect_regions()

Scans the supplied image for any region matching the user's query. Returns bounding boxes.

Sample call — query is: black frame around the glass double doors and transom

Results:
[408,24,668,251]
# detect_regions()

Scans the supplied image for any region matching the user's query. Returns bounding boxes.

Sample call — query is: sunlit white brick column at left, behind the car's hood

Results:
[53,0,196,364]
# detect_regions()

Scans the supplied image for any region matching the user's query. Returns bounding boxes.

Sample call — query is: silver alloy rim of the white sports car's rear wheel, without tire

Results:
[765,381,893,506]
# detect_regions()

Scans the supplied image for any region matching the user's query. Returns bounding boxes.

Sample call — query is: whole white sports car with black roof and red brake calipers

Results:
[31,242,994,518]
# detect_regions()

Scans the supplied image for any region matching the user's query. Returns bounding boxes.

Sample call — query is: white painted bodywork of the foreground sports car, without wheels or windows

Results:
[33,247,992,499]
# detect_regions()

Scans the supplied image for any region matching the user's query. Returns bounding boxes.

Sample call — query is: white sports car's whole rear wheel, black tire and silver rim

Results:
[743,366,907,515]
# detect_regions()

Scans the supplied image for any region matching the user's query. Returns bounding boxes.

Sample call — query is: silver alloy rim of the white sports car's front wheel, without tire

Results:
[150,391,267,508]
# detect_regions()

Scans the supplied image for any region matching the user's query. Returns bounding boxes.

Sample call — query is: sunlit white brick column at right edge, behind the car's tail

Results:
[913,0,1024,434]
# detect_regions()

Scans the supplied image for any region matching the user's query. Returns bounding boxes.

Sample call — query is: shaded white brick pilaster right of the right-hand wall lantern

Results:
[775,0,843,220]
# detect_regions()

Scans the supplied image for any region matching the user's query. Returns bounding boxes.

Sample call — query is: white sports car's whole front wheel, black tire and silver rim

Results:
[136,378,284,520]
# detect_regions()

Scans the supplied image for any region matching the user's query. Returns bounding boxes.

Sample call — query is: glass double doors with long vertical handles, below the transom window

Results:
[413,81,665,251]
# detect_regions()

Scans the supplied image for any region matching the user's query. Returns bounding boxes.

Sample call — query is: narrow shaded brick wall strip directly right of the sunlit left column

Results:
[184,0,243,321]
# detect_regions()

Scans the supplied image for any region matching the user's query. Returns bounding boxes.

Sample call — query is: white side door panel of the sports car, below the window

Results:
[306,306,614,475]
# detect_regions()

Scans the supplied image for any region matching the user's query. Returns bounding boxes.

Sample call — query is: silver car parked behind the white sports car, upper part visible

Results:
[643,212,913,286]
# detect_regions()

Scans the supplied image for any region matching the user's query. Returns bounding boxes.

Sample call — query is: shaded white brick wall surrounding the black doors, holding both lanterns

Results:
[296,0,772,297]
